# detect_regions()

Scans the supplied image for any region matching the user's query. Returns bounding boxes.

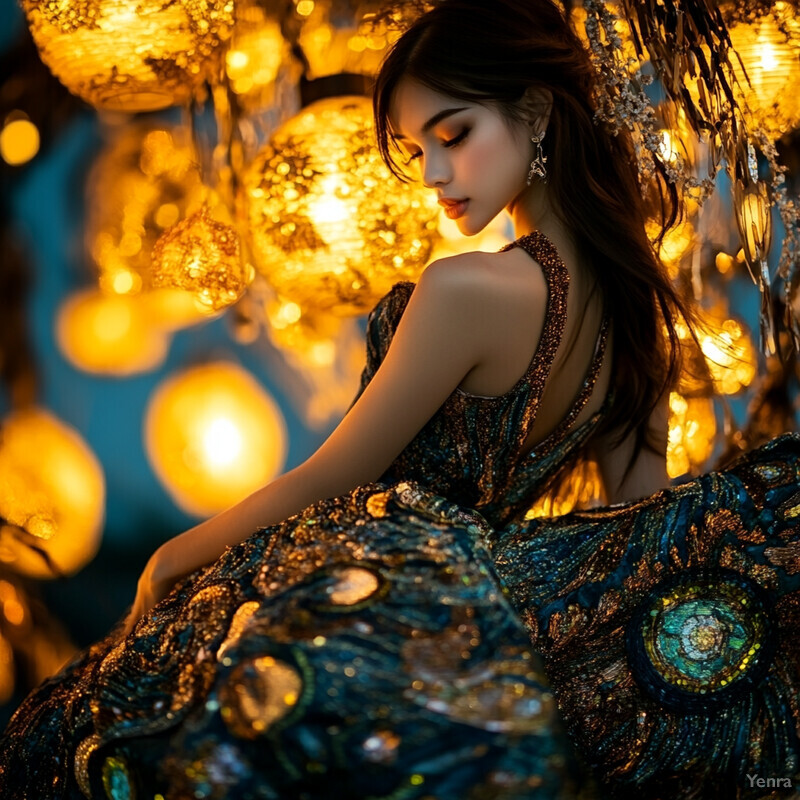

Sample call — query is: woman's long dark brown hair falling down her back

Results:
[373,0,697,484]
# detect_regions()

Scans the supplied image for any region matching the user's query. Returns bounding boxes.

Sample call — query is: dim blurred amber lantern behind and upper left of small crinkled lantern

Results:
[86,125,207,294]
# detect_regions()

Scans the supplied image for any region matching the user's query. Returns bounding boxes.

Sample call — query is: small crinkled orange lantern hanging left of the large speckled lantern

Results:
[151,206,252,311]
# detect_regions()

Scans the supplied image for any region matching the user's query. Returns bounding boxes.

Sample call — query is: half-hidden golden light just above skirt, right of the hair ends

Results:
[667,392,717,478]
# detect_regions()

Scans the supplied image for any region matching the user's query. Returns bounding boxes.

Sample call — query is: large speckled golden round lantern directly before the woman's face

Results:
[243,96,439,316]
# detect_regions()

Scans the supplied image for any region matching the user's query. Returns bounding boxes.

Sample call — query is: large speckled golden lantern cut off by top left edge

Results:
[22,0,233,111]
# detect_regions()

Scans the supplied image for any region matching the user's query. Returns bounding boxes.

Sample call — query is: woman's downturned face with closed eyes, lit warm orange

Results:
[389,78,533,236]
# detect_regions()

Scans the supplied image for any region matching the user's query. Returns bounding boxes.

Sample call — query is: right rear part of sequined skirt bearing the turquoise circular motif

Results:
[492,434,800,800]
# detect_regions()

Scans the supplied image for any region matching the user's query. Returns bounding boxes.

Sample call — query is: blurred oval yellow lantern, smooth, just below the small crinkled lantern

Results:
[56,289,169,375]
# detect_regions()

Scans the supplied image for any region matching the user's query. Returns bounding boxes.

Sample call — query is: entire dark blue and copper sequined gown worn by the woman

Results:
[0,232,800,800]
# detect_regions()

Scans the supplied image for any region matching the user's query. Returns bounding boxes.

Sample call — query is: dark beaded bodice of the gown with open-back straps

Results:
[353,231,610,527]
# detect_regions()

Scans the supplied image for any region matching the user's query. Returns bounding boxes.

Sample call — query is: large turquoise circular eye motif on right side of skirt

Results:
[627,570,775,709]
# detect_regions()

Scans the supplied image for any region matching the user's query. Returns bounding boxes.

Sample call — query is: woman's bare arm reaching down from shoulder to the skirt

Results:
[124,254,487,619]
